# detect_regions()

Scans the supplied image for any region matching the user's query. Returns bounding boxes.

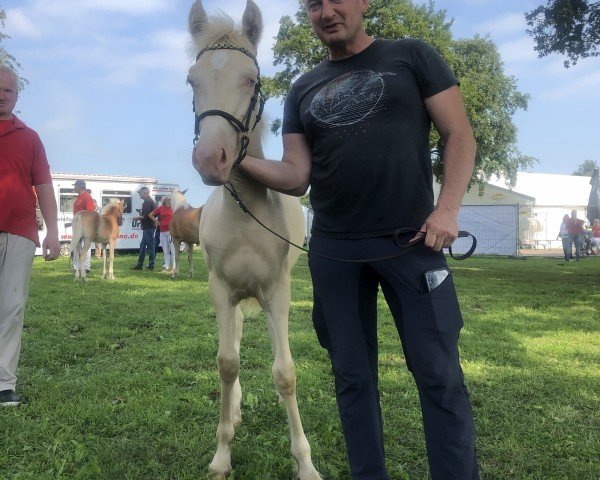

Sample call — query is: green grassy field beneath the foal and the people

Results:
[0,255,600,480]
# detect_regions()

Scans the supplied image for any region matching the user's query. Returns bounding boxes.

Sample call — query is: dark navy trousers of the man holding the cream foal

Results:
[309,236,479,480]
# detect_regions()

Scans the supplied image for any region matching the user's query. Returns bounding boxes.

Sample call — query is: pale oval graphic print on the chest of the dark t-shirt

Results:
[307,70,393,128]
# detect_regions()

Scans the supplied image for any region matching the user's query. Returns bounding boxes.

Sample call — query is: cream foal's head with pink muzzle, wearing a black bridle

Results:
[187,0,262,185]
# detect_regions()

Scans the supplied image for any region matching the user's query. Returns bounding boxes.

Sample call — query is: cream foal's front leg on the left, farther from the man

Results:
[208,274,241,480]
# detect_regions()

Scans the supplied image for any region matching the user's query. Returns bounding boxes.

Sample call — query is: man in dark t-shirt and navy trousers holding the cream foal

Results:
[220,0,479,480]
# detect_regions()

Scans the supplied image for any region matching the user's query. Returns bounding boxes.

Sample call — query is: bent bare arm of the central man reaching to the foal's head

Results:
[240,133,312,197]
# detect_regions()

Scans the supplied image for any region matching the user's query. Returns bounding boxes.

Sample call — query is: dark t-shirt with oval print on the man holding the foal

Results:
[283,39,458,238]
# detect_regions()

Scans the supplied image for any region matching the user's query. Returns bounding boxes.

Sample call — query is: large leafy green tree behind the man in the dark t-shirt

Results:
[265,0,534,188]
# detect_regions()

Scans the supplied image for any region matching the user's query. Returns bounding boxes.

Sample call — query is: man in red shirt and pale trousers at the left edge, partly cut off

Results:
[0,64,60,407]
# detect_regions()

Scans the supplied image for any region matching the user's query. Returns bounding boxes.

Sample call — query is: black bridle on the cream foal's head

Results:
[192,43,265,166]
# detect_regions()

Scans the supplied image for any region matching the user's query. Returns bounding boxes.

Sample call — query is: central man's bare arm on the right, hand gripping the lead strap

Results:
[415,86,476,250]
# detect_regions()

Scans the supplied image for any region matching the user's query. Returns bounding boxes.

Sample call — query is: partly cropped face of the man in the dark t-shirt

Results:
[305,0,368,47]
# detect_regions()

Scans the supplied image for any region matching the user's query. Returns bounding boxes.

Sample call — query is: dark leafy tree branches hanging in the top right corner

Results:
[525,0,600,68]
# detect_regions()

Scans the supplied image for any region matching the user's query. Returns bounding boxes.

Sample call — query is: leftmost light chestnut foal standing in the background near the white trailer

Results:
[71,198,125,282]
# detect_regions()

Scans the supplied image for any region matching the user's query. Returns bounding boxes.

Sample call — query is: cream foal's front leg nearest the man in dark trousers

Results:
[261,278,322,480]
